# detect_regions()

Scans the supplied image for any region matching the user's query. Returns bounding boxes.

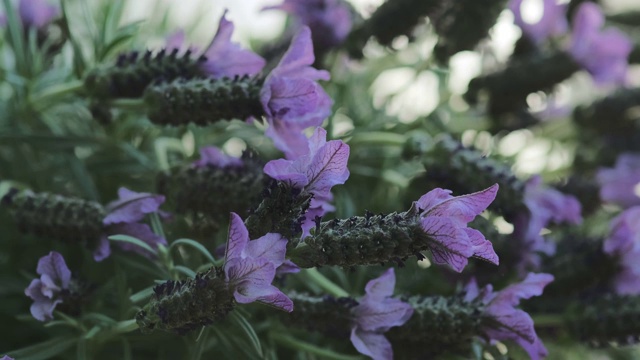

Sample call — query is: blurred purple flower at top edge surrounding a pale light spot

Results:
[509,0,569,43]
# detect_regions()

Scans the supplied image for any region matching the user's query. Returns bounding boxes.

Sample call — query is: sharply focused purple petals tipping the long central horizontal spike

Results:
[415,184,498,272]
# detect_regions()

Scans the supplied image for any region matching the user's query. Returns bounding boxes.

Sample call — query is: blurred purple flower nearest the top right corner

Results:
[569,2,633,84]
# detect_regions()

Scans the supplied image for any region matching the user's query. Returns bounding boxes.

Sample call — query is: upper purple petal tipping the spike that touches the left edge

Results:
[102,187,165,225]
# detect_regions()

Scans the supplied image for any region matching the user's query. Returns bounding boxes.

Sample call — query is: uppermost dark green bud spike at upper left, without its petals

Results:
[85,49,206,99]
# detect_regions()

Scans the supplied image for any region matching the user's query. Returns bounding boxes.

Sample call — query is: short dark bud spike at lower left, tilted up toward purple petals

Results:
[136,268,235,335]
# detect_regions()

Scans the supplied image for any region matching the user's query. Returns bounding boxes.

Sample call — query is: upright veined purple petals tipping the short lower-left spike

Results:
[224,213,293,312]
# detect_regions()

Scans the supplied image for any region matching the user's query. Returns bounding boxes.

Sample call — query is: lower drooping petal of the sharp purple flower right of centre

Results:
[421,216,473,272]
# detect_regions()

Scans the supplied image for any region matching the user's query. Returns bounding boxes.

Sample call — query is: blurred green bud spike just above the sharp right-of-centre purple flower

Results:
[423,136,525,216]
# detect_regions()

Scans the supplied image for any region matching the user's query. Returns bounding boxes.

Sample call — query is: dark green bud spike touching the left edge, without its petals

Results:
[2,190,106,249]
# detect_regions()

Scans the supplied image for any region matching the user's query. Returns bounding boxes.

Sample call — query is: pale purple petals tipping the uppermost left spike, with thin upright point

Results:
[202,12,265,77]
